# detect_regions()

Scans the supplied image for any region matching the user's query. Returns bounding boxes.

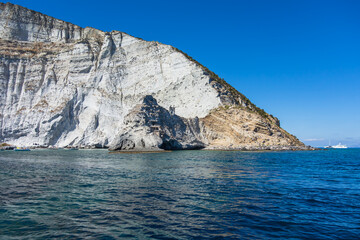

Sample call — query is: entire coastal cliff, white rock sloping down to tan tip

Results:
[0,3,303,149]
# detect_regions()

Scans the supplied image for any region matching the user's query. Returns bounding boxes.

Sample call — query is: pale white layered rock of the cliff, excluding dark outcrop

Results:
[0,3,306,150]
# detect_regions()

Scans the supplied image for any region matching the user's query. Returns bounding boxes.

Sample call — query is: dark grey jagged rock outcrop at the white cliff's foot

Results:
[111,95,205,150]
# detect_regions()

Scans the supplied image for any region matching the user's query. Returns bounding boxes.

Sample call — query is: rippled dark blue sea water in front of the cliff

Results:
[0,149,360,239]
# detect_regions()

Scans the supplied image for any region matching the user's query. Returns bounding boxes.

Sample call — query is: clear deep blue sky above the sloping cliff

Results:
[5,0,360,147]
